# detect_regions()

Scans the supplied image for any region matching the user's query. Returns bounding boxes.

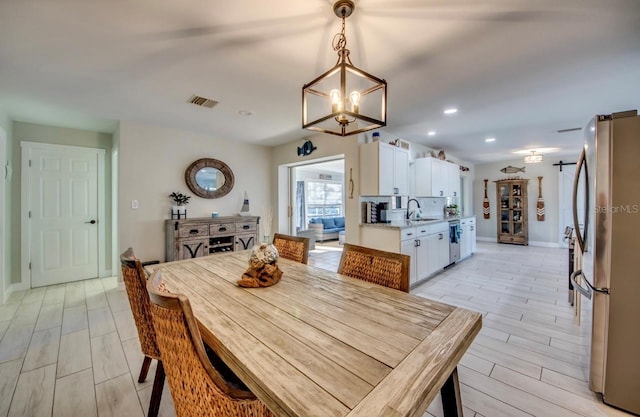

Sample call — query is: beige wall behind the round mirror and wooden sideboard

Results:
[117,122,271,260]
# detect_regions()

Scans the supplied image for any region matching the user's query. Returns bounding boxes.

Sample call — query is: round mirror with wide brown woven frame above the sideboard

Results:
[184,158,234,198]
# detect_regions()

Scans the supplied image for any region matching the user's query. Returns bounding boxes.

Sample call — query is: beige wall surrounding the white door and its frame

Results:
[11,122,112,283]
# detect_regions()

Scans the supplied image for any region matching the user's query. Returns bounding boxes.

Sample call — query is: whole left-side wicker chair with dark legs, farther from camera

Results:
[120,248,165,417]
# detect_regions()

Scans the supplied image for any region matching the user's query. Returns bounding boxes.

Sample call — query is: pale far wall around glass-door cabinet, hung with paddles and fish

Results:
[473,158,559,245]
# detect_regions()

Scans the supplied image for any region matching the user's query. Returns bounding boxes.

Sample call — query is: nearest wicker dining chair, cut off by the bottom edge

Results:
[147,271,275,417]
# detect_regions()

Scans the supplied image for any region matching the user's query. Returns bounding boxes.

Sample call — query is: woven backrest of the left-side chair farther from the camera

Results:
[120,248,160,359]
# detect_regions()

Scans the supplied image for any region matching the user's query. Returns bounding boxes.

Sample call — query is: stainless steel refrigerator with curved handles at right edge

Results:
[571,110,640,414]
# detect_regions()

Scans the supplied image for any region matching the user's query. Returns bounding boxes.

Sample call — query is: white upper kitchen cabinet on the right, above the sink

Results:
[414,158,460,197]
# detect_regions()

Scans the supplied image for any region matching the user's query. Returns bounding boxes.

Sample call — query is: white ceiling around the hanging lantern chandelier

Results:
[0,0,640,162]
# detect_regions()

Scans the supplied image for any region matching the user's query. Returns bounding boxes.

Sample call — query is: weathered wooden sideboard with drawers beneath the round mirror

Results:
[165,216,260,262]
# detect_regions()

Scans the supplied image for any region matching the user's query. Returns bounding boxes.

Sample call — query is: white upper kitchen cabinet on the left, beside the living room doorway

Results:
[360,141,409,196]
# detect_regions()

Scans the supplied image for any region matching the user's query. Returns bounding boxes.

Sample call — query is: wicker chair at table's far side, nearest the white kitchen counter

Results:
[338,243,411,292]
